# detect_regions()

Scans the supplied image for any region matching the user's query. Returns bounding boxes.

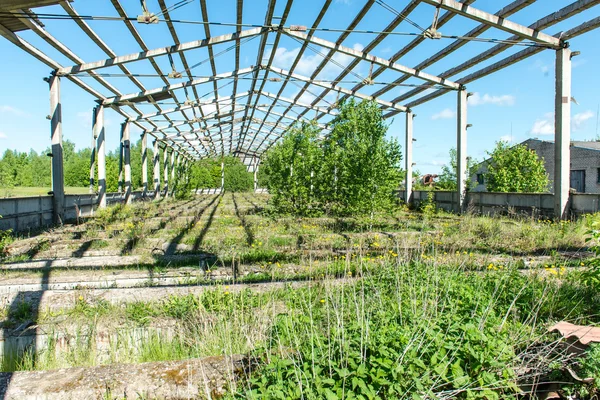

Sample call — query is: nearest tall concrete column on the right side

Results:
[554,48,571,219]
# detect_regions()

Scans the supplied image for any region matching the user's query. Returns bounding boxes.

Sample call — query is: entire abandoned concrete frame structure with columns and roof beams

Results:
[0,0,600,222]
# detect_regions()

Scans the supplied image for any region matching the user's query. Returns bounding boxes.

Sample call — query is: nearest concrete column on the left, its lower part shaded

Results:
[48,75,65,224]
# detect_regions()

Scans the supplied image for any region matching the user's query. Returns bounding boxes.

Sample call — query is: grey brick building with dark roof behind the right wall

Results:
[471,139,600,194]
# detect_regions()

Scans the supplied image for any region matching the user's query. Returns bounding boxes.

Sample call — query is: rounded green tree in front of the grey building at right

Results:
[484,142,548,193]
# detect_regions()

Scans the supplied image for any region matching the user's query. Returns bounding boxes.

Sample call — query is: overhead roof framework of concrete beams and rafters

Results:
[0,0,600,162]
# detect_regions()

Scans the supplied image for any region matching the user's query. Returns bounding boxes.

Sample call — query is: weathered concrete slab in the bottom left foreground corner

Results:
[0,355,244,400]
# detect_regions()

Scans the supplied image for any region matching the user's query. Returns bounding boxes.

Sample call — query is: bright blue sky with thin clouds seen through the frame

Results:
[0,0,600,173]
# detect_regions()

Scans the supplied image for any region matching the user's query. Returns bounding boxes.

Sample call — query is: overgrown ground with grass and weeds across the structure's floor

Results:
[0,193,600,399]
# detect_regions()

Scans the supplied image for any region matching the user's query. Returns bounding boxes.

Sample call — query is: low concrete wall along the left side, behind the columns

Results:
[0,192,154,232]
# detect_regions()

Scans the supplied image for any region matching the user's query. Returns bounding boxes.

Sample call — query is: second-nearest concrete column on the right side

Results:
[455,88,468,213]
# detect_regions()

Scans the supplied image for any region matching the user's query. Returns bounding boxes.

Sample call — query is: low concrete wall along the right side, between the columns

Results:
[398,190,600,218]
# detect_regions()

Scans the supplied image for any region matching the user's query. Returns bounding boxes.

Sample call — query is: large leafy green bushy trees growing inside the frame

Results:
[262,100,402,215]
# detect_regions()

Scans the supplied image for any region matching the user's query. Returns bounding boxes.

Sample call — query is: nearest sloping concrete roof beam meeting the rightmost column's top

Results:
[422,0,562,49]
